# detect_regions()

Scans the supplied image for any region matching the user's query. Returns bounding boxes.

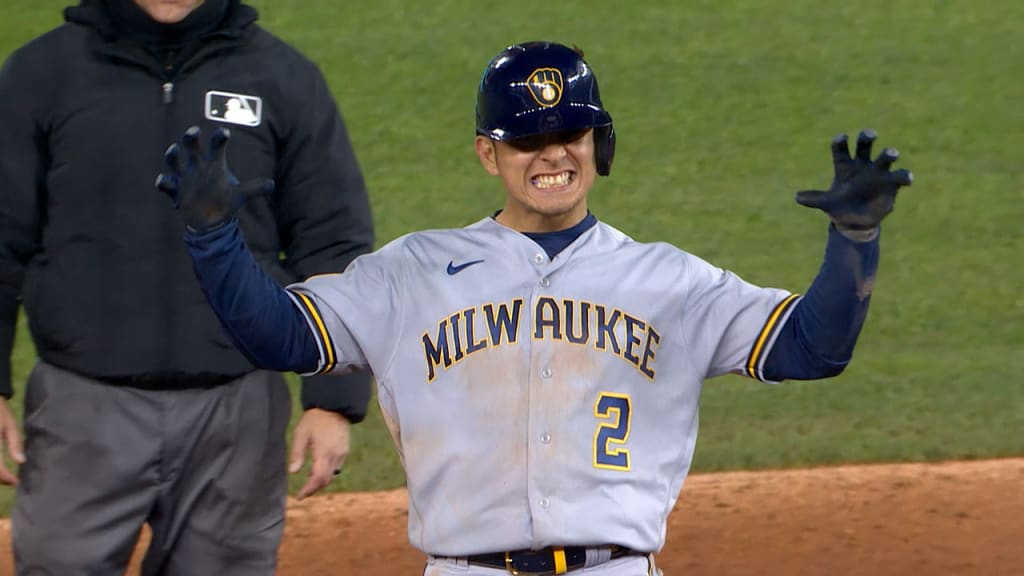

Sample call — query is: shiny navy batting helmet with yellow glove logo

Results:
[476,42,615,176]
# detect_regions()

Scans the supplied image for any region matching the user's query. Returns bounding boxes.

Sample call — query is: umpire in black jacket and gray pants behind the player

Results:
[0,0,373,576]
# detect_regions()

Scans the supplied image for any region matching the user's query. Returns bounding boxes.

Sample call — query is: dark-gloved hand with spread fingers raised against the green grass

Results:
[797,129,913,231]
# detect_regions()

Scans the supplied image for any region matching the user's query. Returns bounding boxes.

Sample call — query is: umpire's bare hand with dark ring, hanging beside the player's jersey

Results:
[289,408,351,500]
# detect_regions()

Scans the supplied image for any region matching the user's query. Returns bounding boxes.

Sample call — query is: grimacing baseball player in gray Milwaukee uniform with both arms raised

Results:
[157,42,910,576]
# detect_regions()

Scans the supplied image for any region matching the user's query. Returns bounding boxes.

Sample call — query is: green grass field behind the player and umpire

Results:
[0,0,1024,511]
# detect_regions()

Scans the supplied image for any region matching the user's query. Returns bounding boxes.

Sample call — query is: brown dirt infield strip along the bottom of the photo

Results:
[0,459,1024,576]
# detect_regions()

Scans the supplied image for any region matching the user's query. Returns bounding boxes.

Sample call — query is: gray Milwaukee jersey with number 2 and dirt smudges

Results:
[290,214,797,556]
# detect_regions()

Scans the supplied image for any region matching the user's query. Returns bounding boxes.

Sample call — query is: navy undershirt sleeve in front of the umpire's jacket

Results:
[185,219,319,373]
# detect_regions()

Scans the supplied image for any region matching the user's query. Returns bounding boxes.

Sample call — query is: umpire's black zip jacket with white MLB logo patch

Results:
[0,0,373,420]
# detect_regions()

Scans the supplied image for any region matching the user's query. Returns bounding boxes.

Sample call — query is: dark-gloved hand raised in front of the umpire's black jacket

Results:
[157,126,273,233]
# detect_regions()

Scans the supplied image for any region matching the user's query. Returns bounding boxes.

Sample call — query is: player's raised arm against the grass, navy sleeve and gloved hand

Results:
[762,130,912,380]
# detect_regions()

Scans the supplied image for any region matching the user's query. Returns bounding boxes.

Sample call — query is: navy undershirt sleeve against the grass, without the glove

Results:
[763,225,879,381]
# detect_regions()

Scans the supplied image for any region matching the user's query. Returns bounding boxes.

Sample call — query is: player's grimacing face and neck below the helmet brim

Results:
[476,129,597,232]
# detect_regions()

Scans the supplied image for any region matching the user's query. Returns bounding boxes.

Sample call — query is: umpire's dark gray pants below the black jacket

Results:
[11,363,291,576]
